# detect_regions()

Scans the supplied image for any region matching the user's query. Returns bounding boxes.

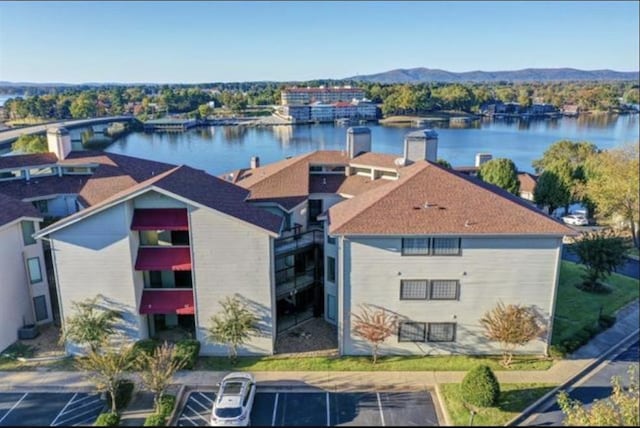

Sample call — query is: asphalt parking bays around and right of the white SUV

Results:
[178,387,438,426]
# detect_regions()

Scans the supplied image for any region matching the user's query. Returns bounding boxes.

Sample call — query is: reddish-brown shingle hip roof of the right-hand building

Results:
[329,161,574,236]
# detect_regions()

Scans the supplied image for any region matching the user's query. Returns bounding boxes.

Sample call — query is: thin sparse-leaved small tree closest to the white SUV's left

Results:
[137,342,185,412]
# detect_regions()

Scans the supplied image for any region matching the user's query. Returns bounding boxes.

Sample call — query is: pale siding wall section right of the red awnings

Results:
[190,208,274,355]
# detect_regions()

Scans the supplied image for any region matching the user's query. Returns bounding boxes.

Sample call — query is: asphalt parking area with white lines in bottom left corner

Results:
[0,392,105,426]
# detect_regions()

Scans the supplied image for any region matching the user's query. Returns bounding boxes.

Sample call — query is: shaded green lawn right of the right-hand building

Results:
[551,261,640,344]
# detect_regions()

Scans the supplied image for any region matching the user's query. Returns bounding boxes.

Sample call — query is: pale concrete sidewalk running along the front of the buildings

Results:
[0,301,640,391]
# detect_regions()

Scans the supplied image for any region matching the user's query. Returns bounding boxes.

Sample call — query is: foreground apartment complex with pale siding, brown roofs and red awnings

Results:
[0,127,573,355]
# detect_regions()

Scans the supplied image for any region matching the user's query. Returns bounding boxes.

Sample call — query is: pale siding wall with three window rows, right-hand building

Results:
[343,238,561,354]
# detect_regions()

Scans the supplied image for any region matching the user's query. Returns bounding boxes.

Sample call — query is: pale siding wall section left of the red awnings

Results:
[51,202,141,353]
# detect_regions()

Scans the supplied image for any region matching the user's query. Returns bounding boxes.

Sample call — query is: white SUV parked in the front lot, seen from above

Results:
[210,373,256,427]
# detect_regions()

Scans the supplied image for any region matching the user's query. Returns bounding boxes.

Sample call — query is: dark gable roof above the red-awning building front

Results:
[37,165,282,237]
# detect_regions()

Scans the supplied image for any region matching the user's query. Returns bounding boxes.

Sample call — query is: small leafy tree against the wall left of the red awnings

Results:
[61,296,122,351]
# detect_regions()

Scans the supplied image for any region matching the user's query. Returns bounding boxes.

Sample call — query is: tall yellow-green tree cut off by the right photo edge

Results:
[586,142,640,247]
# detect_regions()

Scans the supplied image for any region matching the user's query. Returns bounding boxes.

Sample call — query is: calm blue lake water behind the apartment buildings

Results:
[105,114,640,175]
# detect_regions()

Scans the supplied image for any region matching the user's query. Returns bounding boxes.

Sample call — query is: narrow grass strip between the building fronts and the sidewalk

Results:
[196,355,553,371]
